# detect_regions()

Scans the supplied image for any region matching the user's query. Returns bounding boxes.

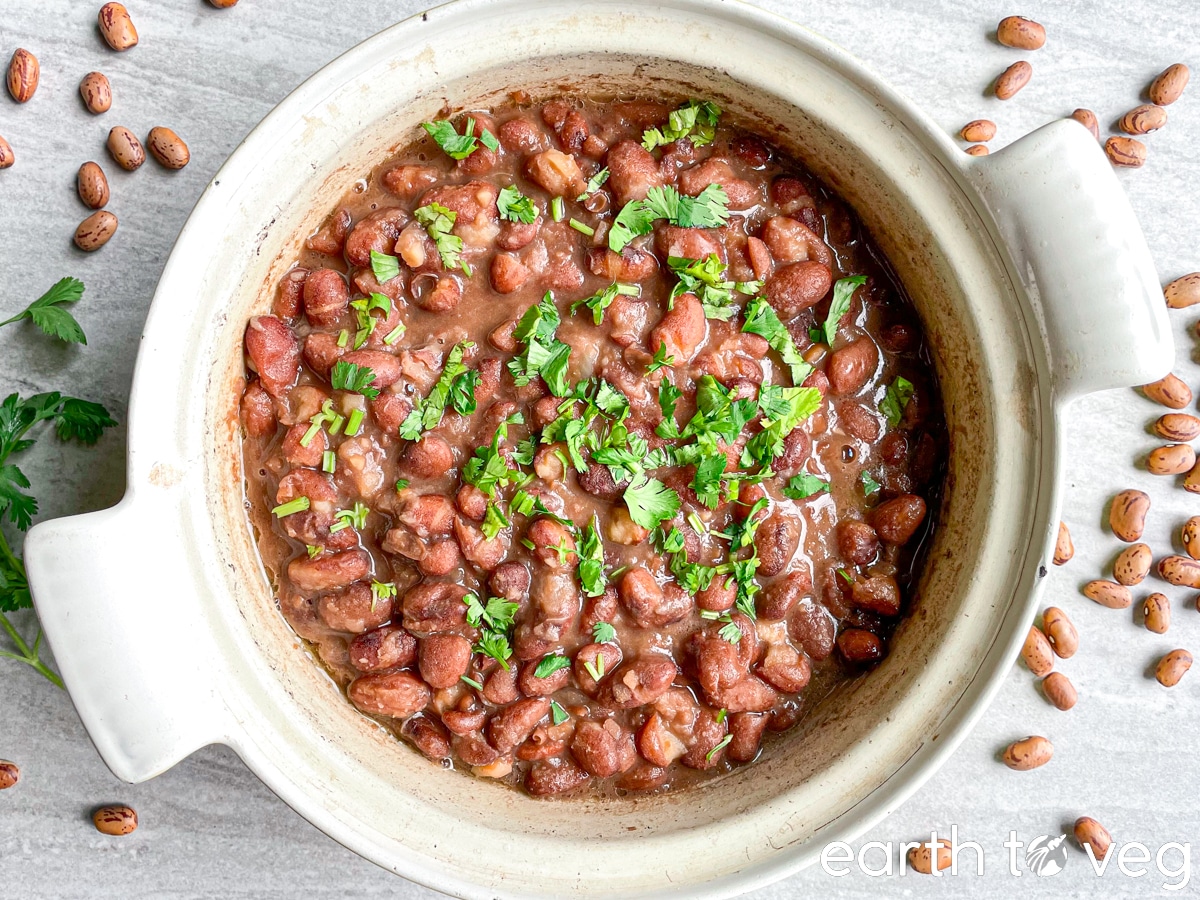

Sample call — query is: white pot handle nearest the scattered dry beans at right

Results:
[964,119,1175,401]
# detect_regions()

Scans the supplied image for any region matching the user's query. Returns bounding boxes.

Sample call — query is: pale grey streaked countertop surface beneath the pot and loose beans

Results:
[0,0,1200,900]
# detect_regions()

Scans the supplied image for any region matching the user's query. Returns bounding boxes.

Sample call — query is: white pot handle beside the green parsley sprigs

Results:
[24,494,229,782]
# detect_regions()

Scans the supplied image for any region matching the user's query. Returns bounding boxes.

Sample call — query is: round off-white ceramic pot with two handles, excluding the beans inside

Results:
[25,0,1174,898]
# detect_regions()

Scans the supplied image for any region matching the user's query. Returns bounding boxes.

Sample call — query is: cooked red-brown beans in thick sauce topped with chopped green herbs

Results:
[241,96,944,797]
